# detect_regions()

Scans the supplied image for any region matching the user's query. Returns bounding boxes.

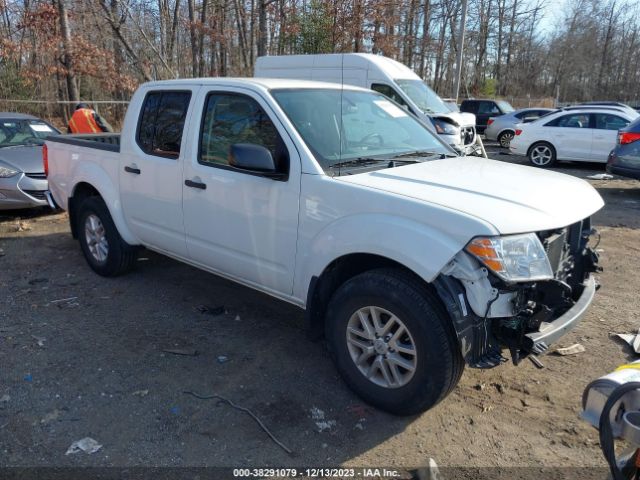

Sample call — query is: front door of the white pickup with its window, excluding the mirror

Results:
[183,89,300,295]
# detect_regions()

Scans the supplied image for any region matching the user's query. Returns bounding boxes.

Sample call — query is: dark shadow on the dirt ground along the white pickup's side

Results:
[0,233,424,467]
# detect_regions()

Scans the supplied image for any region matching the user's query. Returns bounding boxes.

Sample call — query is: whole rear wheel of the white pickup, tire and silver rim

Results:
[77,197,137,277]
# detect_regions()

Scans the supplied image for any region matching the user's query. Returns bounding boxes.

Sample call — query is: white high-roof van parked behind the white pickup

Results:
[254,53,479,155]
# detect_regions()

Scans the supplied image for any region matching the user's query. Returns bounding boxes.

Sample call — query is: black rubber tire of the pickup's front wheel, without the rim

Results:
[325,269,464,415]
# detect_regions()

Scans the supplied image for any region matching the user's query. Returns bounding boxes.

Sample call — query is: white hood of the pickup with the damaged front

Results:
[338,157,604,234]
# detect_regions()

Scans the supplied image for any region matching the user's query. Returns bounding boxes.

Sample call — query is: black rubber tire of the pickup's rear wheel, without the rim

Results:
[76,197,138,277]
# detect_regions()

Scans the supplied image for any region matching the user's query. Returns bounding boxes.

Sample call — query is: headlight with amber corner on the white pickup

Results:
[466,233,553,282]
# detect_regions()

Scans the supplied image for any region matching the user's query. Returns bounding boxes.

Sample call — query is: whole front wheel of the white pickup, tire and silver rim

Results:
[325,269,464,415]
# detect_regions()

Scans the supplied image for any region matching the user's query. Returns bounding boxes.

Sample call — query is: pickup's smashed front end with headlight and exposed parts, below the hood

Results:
[435,218,600,368]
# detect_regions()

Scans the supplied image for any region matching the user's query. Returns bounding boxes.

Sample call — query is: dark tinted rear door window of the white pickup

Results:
[136,91,191,158]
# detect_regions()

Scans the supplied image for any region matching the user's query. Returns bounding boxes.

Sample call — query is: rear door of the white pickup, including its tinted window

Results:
[119,88,195,257]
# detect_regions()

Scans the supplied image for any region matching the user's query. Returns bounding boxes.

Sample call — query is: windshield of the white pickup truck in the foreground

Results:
[272,89,454,171]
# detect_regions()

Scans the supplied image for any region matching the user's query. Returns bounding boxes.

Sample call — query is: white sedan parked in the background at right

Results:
[509,107,636,167]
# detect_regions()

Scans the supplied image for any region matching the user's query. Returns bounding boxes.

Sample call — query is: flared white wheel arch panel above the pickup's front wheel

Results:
[294,213,468,299]
